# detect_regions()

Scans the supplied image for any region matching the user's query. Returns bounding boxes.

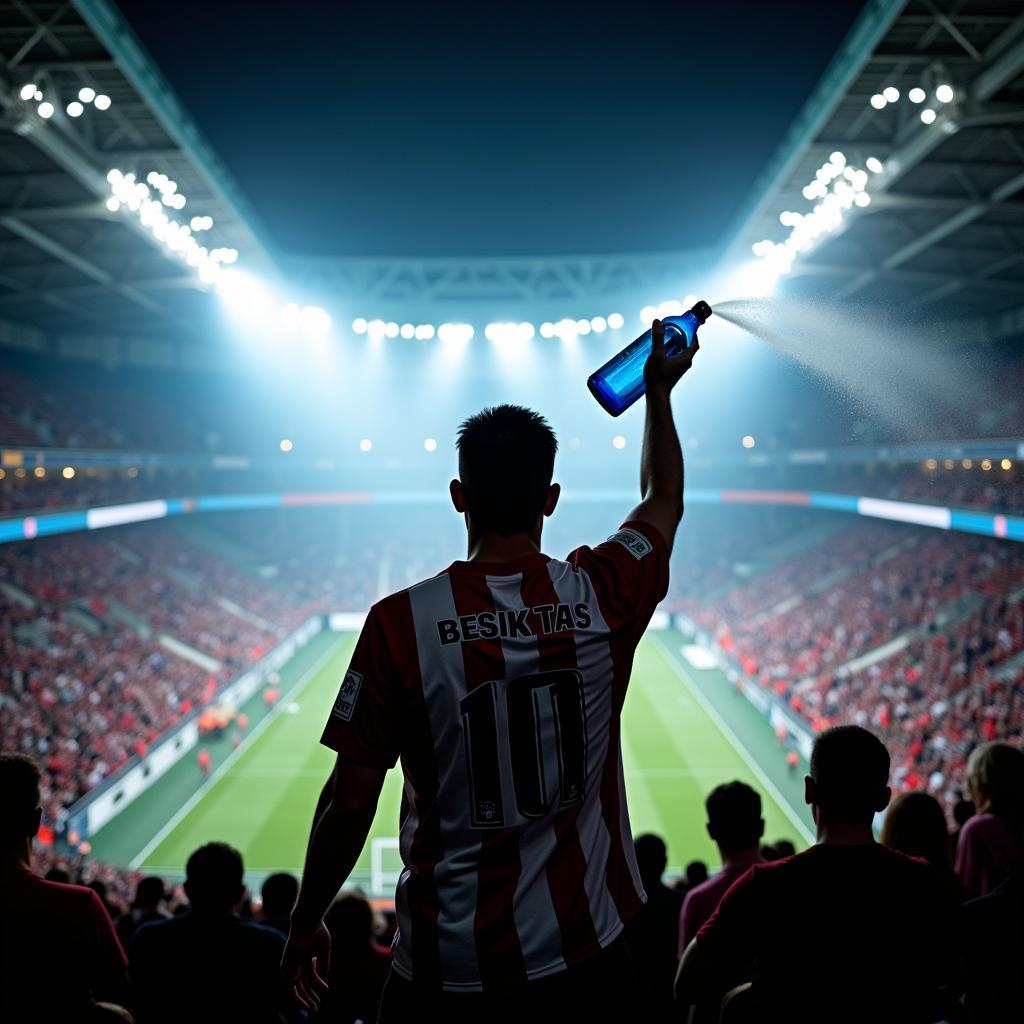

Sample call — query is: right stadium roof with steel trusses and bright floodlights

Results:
[725,0,1024,339]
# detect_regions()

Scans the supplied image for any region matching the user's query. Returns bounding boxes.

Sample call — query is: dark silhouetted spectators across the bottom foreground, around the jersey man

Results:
[0,726,1024,1024]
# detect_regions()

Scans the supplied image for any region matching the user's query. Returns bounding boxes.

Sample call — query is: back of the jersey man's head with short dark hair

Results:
[456,406,558,537]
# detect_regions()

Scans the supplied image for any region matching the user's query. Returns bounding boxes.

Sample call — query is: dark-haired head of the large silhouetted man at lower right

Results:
[811,725,889,824]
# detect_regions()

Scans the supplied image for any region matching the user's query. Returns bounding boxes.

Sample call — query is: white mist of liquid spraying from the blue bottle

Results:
[713,298,992,437]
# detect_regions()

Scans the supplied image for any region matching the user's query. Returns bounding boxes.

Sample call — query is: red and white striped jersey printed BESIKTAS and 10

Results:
[323,522,669,991]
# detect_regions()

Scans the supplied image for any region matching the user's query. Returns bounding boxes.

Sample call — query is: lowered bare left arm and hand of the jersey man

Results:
[282,755,387,1011]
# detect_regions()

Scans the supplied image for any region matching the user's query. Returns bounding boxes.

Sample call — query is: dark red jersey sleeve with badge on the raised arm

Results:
[568,520,669,639]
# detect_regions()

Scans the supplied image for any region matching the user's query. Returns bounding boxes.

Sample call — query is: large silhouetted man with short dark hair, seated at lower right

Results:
[676,726,958,1024]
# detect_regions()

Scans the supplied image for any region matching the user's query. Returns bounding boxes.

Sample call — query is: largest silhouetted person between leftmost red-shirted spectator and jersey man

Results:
[129,843,285,1024]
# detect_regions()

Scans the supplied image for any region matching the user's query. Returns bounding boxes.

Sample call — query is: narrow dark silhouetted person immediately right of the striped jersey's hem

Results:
[627,834,683,1015]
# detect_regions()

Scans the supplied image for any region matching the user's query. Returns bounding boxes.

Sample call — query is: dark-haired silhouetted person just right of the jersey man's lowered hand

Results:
[316,890,391,1024]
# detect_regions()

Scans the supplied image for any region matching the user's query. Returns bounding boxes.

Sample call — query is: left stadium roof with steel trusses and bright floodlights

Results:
[0,0,270,343]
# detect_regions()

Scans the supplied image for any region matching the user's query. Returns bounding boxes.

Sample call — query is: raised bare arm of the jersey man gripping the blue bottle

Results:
[626,321,700,553]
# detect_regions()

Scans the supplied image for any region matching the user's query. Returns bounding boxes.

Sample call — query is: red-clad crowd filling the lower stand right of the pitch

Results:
[679,523,1024,816]
